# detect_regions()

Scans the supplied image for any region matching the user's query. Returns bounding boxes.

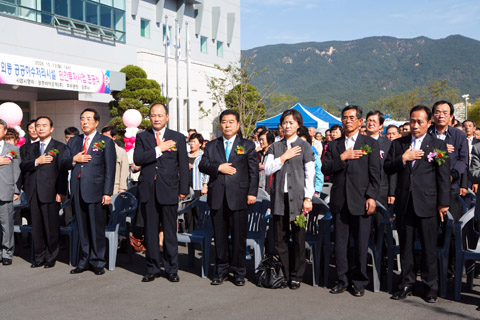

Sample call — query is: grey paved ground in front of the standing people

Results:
[0,242,480,320]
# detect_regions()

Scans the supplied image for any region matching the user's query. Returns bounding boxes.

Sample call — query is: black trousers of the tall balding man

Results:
[141,184,178,274]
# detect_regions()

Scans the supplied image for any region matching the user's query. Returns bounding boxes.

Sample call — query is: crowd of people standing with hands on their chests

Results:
[0,101,480,303]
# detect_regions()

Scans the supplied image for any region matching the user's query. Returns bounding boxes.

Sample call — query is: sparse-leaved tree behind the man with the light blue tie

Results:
[204,58,267,136]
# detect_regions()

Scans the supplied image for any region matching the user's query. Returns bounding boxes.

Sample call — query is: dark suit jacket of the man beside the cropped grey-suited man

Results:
[20,139,68,203]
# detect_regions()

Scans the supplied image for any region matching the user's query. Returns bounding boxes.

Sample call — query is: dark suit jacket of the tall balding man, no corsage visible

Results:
[133,128,190,205]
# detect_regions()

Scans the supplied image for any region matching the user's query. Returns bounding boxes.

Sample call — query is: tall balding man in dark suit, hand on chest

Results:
[133,103,189,282]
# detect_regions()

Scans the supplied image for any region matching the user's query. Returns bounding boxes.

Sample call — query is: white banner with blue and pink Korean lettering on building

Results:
[0,53,110,93]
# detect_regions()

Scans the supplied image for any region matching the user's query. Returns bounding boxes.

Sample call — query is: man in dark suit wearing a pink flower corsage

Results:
[384,106,450,303]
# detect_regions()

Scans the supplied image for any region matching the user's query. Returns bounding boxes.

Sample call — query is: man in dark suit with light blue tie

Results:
[198,109,259,286]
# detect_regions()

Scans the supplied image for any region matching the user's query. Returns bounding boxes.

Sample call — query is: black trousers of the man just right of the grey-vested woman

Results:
[335,203,373,289]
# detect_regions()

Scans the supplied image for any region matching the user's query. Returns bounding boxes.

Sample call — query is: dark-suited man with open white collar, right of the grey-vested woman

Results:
[322,105,380,297]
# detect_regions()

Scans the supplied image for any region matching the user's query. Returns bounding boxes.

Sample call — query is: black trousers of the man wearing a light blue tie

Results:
[211,198,248,278]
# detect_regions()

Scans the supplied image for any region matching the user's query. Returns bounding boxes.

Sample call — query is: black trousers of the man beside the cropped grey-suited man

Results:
[30,192,60,263]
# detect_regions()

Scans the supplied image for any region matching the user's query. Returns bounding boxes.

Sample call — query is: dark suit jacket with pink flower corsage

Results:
[384,134,450,218]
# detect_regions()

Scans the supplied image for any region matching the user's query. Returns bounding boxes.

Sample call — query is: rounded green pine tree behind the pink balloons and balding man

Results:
[108,65,167,135]
